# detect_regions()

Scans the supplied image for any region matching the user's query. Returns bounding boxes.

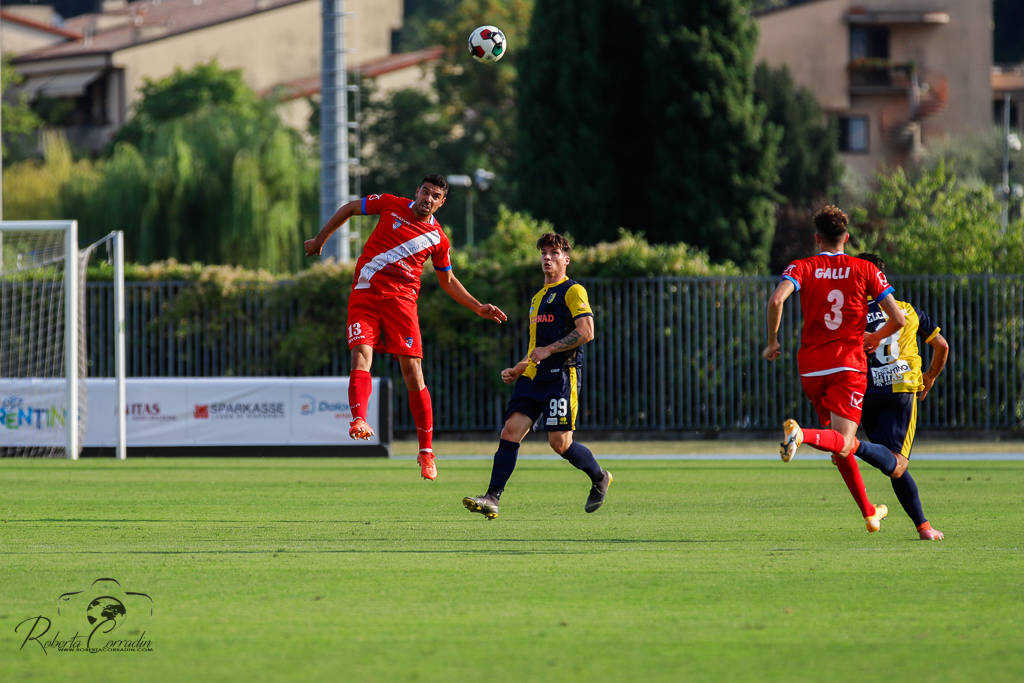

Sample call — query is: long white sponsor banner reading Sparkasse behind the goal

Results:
[0,377,380,447]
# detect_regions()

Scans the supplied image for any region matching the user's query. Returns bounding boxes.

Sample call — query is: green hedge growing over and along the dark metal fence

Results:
[90,215,739,375]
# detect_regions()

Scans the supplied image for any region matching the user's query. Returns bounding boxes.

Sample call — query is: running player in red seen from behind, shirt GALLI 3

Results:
[761,205,906,531]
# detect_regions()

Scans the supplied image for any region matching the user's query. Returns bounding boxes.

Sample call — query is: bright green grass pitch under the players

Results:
[0,452,1024,683]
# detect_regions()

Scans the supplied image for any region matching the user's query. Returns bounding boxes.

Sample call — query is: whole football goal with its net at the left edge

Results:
[0,221,125,459]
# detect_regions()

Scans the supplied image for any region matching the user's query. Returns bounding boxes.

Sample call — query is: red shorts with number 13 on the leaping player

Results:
[347,291,423,358]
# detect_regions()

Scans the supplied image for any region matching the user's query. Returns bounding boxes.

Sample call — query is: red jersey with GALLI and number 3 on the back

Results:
[782,252,893,377]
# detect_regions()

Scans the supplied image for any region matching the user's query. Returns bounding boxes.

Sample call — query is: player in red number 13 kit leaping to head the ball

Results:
[305,174,508,479]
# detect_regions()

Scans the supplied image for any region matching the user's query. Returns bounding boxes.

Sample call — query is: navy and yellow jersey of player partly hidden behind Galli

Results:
[866,301,939,393]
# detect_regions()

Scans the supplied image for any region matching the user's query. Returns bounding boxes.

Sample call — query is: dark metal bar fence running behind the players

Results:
[81,275,1024,433]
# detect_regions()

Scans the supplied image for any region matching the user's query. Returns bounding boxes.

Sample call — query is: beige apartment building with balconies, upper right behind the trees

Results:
[757,0,992,176]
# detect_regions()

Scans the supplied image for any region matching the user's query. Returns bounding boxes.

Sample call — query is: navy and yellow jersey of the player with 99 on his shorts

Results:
[523,278,594,380]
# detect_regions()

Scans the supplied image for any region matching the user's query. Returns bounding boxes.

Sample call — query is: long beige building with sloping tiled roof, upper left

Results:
[5,0,403,150]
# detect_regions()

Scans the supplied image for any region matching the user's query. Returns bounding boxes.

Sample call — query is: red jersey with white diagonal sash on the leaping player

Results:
[352,195,452,301]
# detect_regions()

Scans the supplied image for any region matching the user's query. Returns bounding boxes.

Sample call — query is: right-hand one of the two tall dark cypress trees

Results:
[642,0,778,268]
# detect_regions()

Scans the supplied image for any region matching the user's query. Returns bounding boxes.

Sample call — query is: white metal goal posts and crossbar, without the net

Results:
[0,220,128,460]
